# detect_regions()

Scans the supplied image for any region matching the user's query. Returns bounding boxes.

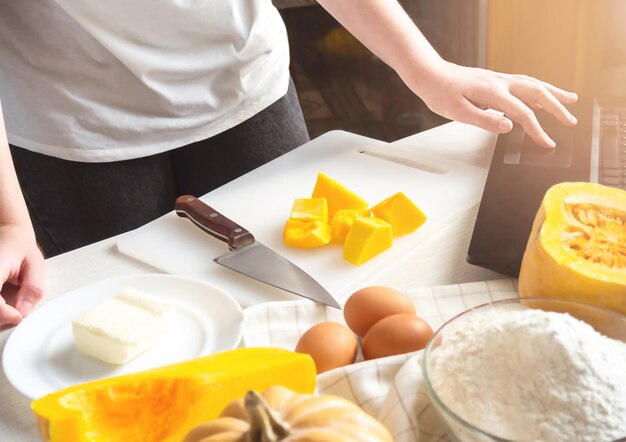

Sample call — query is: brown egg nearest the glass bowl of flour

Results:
[362,314,433,359]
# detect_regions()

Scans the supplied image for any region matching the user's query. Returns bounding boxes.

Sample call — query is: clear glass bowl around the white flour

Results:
[422,298,626,442]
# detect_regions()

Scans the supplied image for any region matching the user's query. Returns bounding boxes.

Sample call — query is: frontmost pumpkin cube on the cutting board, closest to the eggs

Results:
[343,218,393,265]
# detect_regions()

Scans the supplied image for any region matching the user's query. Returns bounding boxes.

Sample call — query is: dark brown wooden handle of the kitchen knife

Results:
[174,195,254,250]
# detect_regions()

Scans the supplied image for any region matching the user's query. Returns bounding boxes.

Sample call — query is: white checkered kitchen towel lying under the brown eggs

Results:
[244,279,517,442]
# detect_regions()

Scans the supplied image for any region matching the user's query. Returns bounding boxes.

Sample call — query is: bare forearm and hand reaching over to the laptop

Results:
[318,0,577,148]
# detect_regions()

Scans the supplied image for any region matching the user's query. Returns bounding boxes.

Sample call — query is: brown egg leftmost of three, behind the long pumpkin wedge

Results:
[296,322,357,373]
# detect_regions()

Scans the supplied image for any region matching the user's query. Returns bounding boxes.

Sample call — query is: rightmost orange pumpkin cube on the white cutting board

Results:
[372,192,426,236]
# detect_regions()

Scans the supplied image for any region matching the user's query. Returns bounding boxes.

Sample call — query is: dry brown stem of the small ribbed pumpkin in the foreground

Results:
[245,390,289,442]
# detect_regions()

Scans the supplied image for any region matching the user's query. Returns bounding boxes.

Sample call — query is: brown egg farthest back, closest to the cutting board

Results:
[343,286,415,336]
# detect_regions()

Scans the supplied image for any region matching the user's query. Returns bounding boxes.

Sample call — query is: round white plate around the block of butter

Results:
[2,274,243,399]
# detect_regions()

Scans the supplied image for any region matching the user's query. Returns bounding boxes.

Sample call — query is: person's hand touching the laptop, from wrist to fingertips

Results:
[403,60,578,148]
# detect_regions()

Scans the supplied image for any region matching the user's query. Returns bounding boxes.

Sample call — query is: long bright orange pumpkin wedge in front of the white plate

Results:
[32,348,316,442]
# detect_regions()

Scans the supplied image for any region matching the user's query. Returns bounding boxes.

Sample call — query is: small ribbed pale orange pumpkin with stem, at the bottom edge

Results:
[184,386,393,442]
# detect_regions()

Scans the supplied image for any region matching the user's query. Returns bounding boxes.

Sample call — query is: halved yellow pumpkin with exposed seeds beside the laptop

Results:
[519,183,626,314]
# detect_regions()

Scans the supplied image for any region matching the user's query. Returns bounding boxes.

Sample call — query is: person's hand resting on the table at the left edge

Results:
[0,224,45,326]
